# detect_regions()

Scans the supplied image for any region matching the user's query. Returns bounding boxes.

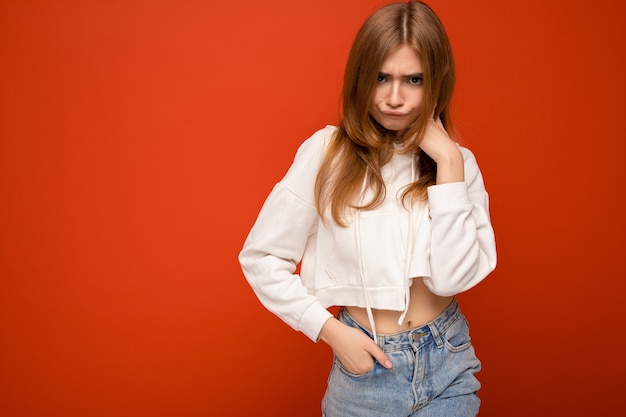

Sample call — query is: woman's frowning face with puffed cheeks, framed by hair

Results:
[370,45,424,130]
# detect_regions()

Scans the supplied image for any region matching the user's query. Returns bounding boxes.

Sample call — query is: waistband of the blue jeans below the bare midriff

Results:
[338,298,463,352]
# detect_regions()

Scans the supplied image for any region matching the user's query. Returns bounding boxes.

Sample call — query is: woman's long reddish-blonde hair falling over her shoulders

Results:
[315,1,455,226]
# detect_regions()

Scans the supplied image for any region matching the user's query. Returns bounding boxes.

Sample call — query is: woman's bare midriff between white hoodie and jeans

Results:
[345,278,453,334]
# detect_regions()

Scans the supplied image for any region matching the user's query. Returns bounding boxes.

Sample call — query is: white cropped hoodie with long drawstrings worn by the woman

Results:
[239,126,496,341]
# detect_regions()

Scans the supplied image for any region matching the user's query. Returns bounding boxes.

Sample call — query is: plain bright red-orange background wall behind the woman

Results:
[0,0,626,417]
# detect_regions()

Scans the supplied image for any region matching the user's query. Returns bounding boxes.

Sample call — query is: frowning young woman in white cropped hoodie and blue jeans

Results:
[239,1,496,417]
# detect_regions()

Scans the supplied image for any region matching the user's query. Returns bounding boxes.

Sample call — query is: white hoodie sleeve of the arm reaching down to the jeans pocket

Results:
[239,127,332,341]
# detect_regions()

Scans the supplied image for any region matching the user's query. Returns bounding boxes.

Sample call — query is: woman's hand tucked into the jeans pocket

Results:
[320,317,392,375]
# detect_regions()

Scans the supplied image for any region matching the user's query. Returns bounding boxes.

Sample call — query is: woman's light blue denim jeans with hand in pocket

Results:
[322,300,480,417]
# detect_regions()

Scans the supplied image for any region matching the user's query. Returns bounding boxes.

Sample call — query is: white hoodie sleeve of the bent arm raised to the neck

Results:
[424,147,496,296]
